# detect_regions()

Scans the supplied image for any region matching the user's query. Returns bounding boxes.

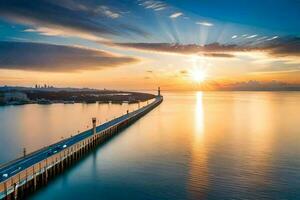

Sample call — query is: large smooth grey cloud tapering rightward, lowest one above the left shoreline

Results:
[0,41,138,72]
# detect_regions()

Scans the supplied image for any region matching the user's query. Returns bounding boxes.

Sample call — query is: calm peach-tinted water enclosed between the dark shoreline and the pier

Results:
[0,101,145,164]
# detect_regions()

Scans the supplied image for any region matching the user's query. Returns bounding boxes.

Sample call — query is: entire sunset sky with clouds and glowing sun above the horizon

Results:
[0,0,300,90]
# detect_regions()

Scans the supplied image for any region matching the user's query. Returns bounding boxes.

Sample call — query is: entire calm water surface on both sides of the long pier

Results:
[0,92,300,200]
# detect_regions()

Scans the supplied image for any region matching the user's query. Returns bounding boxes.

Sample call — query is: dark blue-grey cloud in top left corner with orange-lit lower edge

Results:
[0,0,148,40]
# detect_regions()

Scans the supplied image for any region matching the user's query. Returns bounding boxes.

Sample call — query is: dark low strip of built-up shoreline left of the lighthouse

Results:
[0,88,155,106]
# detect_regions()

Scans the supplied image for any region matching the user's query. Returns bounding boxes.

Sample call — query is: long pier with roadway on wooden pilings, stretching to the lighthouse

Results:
[0,94,163,199]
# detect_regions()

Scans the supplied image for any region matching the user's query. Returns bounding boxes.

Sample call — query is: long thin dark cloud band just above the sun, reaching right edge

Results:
[109,37,300,58]
